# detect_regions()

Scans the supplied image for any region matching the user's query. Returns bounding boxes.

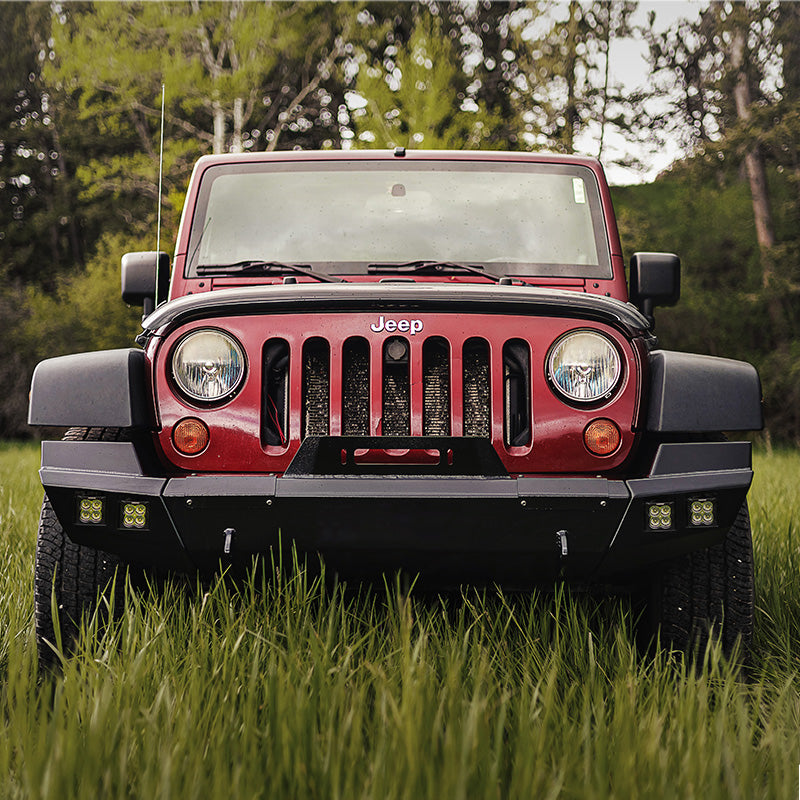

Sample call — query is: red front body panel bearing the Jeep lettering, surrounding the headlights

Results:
[154,313,642,474]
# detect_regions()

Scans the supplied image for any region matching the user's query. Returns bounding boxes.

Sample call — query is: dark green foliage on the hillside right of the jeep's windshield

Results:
[613,164,800,443]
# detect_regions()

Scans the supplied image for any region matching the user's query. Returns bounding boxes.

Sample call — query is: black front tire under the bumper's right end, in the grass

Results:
[650,501,755,657]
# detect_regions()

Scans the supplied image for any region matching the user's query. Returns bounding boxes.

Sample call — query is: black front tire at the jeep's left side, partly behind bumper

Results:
[34,428,125,670]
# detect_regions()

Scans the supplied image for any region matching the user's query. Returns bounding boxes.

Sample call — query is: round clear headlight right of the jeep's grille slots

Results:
[547,331,622,403]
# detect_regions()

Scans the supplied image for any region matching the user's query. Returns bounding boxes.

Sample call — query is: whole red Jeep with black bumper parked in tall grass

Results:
[29,149,762,660]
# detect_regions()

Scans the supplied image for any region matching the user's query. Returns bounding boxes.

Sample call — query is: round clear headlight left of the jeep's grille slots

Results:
[172,330,245,403]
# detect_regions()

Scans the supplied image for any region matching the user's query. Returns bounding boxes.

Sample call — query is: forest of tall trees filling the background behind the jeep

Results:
[0,0,800,445]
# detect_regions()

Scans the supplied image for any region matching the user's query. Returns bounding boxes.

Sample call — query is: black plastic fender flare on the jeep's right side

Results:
[647,350,764,433]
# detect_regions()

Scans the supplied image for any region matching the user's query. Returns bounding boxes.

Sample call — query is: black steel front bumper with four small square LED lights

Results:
[40,441,752,587]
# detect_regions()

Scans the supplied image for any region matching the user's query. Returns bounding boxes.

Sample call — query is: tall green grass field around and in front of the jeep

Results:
[0,445,800,800]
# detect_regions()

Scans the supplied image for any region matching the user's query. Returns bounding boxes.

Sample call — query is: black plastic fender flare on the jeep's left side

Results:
[28,348,155,428]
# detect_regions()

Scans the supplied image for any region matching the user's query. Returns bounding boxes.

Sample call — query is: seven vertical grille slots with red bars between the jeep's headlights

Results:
[262,336,532,447]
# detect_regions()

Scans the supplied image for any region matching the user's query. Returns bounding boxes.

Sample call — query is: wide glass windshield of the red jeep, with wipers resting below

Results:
[188,159,611,278]
